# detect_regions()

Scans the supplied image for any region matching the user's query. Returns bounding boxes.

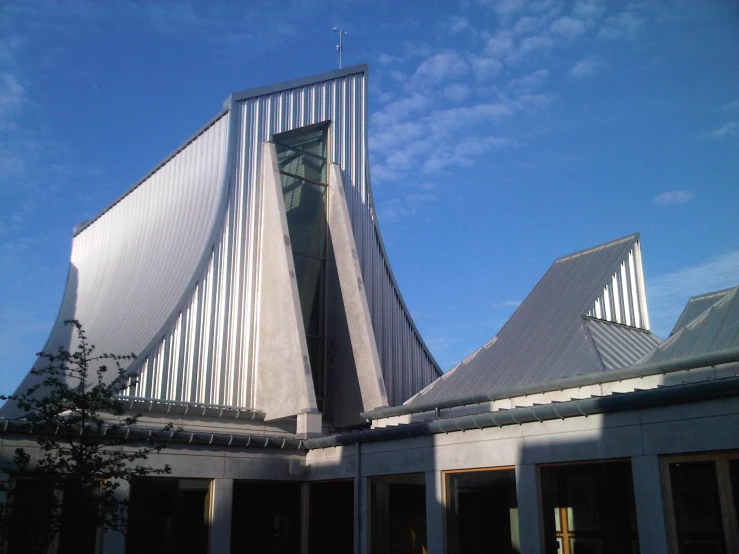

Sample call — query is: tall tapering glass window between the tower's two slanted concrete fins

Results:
[274,124,328,411]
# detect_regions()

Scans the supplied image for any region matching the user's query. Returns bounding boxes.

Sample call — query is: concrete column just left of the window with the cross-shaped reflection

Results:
[516,464,548,554]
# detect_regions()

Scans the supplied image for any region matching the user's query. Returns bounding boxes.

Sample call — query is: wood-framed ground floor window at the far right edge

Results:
[663,452,739,554]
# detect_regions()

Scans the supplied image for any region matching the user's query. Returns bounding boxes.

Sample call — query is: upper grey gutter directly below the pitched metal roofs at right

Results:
[360,343,739,419]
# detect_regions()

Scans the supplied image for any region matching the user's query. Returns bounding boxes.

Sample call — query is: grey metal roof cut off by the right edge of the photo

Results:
[640,287,739,363]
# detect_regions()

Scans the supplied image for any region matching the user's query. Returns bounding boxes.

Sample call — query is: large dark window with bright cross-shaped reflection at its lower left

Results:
[541,461,639,554]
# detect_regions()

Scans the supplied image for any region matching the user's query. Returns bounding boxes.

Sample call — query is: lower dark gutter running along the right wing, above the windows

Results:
[305,370,739,450]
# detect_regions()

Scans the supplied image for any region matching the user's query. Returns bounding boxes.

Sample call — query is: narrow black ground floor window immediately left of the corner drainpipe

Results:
[308,480,354,554]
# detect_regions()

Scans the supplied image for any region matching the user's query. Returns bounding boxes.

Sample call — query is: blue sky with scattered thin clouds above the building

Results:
[0,0,739,392]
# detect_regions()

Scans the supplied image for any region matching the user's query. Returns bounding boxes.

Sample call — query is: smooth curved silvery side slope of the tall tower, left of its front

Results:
[0,116,228,414]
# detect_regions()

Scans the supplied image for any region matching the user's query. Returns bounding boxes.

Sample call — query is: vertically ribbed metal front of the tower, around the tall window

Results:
[135,69,441,408]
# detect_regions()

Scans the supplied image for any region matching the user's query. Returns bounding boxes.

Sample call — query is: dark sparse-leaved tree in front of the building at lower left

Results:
[0,320,177,552]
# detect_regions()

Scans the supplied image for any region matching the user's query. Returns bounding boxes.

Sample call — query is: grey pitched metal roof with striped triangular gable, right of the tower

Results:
[408,234,659,405]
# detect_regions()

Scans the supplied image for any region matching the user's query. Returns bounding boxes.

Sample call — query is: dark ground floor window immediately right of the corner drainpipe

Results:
[370,473,428,554]
